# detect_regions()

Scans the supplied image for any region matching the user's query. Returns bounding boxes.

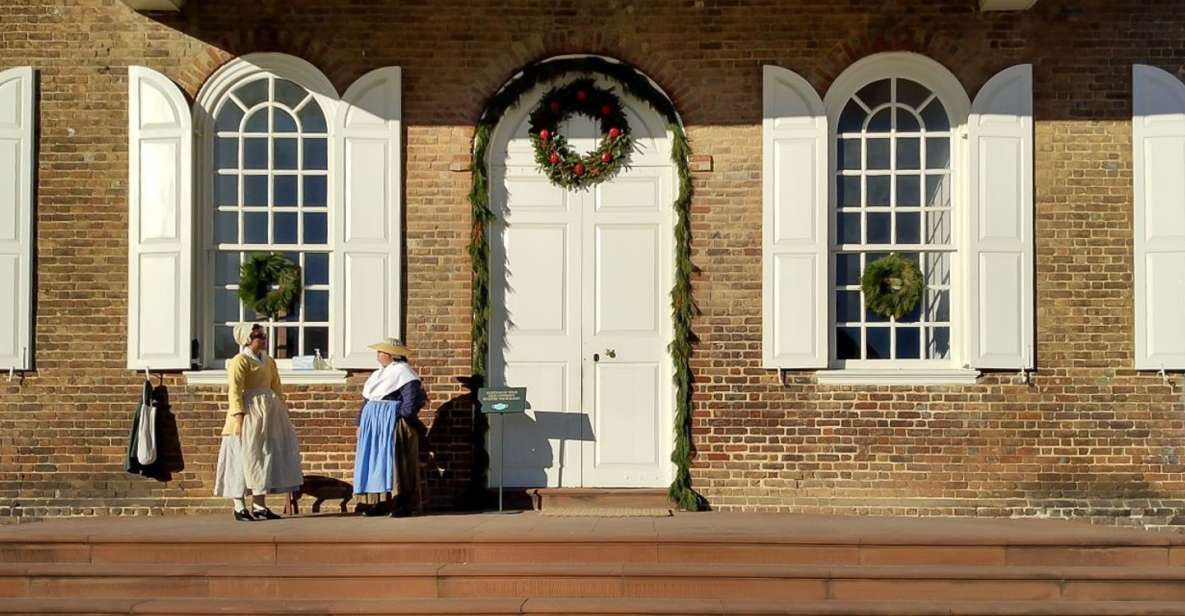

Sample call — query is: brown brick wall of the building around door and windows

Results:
[0,0,1185,525]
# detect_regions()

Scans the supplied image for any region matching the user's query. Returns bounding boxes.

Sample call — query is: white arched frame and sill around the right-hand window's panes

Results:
[819,52,978,376]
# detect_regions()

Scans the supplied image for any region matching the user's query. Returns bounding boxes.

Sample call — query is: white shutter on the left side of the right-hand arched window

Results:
[761,66,831,368]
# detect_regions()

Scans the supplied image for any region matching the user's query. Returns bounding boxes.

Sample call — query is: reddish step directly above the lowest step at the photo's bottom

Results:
[0,563,1185,602]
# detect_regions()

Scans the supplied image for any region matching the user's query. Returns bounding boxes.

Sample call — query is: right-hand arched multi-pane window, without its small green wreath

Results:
[826,54,968,366]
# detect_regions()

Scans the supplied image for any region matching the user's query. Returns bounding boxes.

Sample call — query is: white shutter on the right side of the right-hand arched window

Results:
[966,64,1035,368]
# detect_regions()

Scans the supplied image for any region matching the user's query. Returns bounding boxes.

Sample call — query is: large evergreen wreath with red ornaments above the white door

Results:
[530,78,634,190]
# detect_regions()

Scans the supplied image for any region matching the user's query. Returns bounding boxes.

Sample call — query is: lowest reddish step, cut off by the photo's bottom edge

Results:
[0,598,1185,616]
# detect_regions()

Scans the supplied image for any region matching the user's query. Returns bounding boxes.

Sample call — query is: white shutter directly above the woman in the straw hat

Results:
[331,66,403,368]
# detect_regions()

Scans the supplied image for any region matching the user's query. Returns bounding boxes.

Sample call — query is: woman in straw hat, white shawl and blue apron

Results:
[354,338,425,518]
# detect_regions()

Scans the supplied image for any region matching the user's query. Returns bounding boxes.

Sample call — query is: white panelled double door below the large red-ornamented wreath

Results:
[488,133,674,487]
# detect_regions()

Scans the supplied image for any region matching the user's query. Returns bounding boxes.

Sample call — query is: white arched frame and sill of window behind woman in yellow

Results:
[187,53,346,385]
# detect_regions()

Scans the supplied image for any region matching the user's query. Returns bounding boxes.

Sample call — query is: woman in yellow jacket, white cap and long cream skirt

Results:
[214,323,305,521]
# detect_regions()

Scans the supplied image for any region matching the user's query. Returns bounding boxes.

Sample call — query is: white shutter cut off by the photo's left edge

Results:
[0,66,37,371]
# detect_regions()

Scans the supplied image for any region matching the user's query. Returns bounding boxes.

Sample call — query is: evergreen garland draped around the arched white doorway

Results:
[469,57,707,511]
